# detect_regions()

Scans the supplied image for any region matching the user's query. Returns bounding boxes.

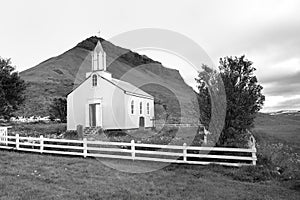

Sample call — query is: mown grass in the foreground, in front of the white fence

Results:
[0,150,300,199]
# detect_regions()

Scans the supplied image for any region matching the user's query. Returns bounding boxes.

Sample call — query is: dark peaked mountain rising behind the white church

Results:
[18,36,198,121]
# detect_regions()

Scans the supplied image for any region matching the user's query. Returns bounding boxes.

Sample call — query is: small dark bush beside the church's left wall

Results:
[49,98,67,123]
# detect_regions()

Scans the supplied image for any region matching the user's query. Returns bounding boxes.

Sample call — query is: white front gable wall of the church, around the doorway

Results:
[67,74,126,130]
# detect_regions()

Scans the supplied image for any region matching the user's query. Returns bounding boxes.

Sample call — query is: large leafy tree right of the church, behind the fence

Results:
[196,56,265,146]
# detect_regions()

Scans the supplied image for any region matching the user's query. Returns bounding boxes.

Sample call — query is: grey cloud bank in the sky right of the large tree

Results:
[226,19,300,104]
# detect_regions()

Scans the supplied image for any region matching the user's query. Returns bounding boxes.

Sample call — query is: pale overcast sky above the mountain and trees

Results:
[0,0,300,112]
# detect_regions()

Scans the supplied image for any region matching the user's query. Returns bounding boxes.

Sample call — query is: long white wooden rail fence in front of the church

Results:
[0,134,257,166]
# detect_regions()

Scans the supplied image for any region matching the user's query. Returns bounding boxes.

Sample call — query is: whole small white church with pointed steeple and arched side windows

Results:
[67,41,154,130]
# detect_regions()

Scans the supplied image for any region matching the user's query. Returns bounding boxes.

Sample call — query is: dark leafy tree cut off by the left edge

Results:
[0,57,26,120]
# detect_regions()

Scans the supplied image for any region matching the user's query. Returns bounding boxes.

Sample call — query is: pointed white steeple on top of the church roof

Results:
[92,40,106,71]
